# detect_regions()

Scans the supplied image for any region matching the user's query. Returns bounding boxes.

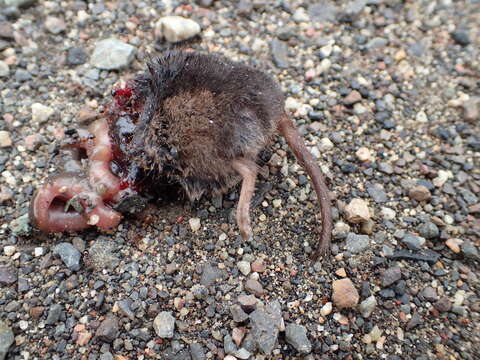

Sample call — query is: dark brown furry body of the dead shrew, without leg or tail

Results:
[122,51,284,200]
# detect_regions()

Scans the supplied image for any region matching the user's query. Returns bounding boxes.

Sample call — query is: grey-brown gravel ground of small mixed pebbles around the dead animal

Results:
[0,0,480,360]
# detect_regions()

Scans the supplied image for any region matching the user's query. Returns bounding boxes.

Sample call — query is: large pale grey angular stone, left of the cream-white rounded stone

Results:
[90,37,136,70]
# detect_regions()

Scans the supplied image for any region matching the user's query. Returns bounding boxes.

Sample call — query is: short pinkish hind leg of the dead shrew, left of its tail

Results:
[232,159,257,240]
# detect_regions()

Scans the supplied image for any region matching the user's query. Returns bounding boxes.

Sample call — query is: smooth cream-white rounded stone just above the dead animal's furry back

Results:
[155,16,201,43]
